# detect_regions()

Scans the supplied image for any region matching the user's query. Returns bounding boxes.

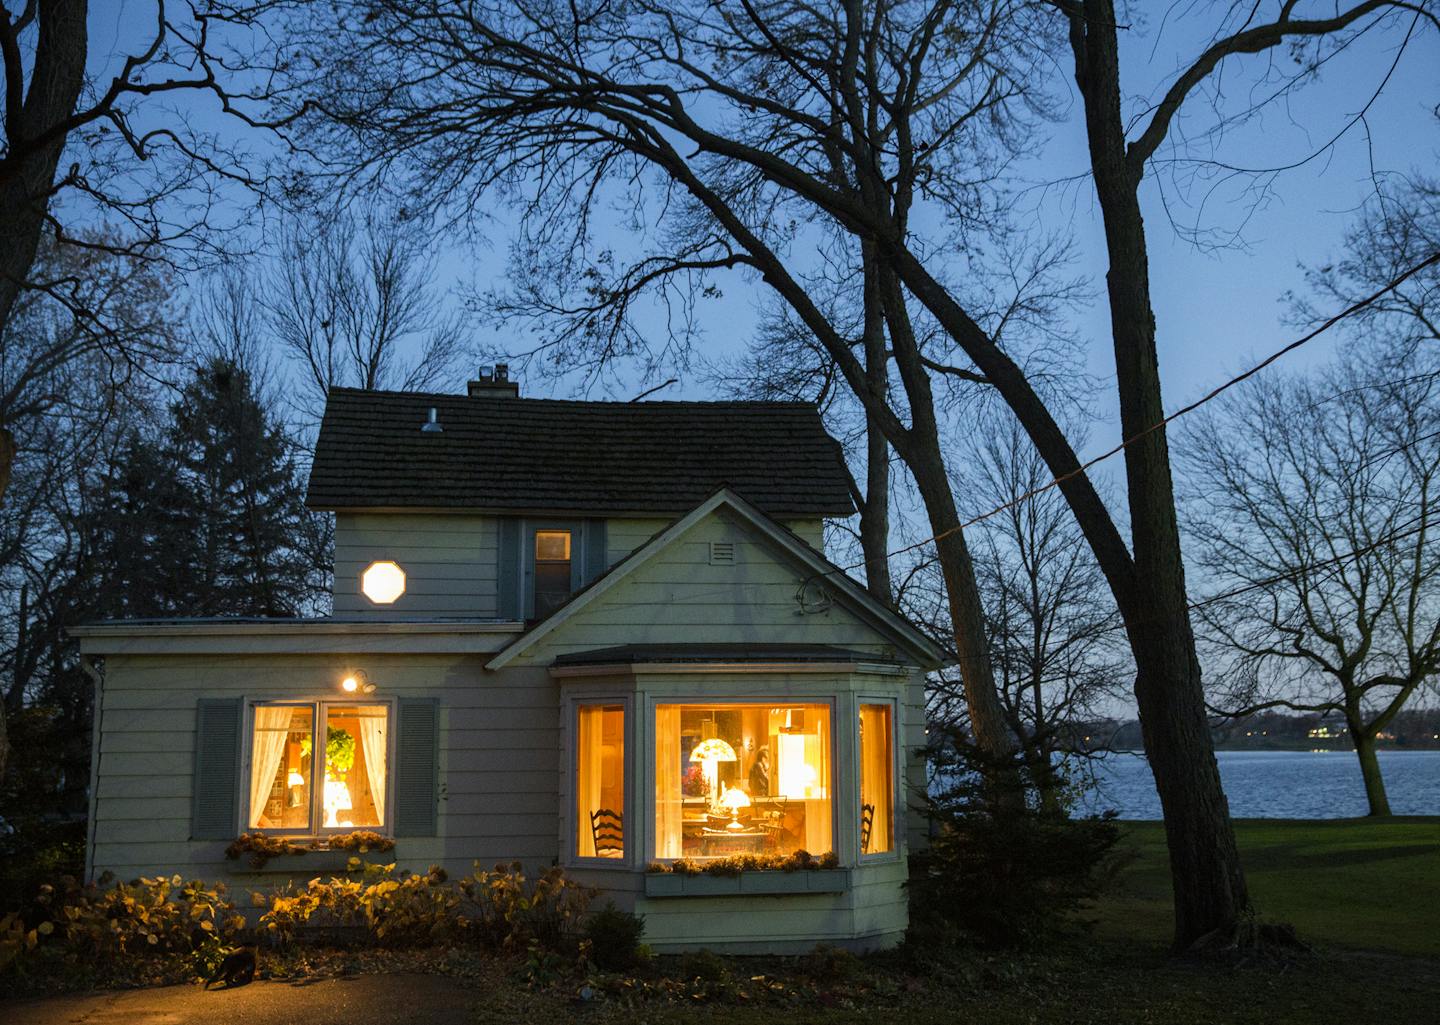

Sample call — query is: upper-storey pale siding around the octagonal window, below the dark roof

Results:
[334,513,824,620]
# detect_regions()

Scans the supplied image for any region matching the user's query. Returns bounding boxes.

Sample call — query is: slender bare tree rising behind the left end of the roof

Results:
[261,210,468,422]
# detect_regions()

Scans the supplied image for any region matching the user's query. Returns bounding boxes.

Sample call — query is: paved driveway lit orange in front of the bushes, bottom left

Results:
[0,975,485,1025]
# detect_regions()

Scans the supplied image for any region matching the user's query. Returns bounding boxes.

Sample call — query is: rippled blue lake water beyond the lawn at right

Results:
[1084,751,1440,819]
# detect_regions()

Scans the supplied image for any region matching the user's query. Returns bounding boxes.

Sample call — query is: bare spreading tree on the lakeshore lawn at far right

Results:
[1184,328,1440,815]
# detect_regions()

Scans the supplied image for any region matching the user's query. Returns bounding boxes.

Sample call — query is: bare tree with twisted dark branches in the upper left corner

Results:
[0,0,292,498]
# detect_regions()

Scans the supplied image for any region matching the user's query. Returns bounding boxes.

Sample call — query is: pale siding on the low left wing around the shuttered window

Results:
[92,655,560,884]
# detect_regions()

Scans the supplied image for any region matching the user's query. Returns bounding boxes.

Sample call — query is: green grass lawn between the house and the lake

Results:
[1097,818,1440,957]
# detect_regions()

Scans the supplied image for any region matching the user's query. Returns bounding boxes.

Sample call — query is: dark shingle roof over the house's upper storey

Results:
[307,389,854,517]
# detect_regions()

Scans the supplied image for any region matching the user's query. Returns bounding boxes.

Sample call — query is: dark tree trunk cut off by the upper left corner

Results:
[0,0,88,331]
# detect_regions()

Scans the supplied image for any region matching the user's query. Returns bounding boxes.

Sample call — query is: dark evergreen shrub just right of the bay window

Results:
[912,805,1120,946]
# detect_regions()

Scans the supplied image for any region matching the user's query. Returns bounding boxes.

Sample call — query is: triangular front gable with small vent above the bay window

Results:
[488,489,943,669]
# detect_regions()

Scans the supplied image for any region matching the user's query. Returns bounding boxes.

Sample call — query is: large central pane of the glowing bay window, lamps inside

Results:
[655,704,834,858]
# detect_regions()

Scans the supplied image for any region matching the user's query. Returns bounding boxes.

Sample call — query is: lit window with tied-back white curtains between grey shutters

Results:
[246,701,390,835]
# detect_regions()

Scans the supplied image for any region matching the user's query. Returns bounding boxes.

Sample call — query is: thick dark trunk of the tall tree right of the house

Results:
[1073,0,1248,949]
